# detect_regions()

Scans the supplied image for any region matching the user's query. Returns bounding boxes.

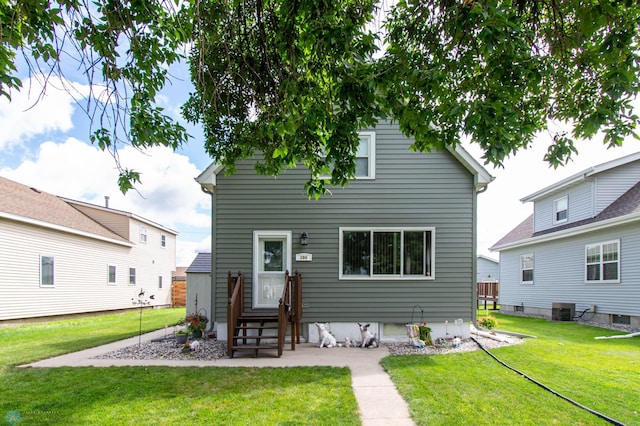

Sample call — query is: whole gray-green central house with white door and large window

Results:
[197,122,492,341]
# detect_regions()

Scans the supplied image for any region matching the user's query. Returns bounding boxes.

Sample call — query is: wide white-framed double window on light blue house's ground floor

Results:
[585,240,620,282]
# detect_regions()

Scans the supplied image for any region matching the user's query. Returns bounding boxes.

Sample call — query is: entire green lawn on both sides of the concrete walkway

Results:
[0,309,640,425]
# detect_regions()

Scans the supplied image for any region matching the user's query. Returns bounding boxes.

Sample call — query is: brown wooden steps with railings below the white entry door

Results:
[227,271,302,358]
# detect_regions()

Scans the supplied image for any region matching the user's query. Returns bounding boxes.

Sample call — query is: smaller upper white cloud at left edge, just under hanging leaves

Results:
[0,75,88,150]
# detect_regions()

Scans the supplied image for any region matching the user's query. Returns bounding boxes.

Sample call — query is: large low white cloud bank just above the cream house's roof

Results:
[0,138,211,265]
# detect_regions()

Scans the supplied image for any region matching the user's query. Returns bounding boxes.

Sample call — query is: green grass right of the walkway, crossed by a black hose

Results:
[383,314,640,425]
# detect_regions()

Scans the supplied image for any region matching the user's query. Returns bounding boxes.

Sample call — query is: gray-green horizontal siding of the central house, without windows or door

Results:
[213,124,476,323]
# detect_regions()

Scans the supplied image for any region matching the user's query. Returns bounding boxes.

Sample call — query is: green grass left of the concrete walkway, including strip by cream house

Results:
[0,309,360,425]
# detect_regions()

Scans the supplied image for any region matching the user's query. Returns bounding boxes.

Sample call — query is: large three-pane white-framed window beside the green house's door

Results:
[340,228,434,279]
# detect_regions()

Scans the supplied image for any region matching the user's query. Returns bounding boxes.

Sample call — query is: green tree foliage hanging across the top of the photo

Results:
[0,0,640,197]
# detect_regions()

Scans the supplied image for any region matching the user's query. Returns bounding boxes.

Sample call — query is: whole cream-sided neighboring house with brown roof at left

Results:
[0,177,177,320]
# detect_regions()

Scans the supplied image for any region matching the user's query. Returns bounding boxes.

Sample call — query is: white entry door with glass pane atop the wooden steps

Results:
[253,231,291,308]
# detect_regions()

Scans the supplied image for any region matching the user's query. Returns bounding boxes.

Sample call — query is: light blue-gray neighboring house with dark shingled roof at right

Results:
[492,152,640,329]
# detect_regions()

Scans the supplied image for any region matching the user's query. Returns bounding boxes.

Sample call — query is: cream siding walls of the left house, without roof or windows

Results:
[0,219,175,320]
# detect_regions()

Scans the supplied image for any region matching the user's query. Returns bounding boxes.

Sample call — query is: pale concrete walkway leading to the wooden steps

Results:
[23,330,415,426]
